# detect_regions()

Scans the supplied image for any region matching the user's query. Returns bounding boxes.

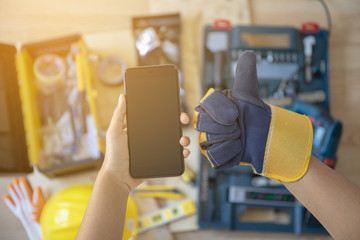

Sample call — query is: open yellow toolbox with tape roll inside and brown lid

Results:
[0,35,104,177]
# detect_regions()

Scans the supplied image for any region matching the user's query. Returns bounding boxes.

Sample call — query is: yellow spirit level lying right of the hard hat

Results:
[138,200,196,233]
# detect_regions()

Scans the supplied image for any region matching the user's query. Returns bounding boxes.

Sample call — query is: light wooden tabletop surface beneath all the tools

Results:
[0,0,360,240]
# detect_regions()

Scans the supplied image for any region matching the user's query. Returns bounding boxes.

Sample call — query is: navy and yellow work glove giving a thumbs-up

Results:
[193,51,313,182]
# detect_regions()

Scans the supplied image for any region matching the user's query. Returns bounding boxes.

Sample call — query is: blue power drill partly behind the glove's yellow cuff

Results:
[291,100,342,168]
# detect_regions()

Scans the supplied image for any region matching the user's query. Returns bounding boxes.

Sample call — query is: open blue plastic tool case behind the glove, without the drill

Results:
[198,26,341,234]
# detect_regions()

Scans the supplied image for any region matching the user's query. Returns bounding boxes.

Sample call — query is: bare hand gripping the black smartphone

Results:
[101,95,190,191]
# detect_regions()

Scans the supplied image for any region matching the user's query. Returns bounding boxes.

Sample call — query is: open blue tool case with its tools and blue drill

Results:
[198,20,342,234]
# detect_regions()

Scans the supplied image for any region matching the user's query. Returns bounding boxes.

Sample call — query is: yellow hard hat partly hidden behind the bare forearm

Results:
[40,184,137,240]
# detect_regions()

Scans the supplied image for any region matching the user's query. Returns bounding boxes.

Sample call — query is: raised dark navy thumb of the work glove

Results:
[231,51,263,108]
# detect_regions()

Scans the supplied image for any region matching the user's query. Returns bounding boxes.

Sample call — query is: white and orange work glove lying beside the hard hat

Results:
[3,177,45,240]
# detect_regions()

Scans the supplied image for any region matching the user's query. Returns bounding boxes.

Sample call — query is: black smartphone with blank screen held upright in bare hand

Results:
[124,65,184,178]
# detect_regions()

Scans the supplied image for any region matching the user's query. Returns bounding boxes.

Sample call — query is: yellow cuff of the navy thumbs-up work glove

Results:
[261,105,313,182]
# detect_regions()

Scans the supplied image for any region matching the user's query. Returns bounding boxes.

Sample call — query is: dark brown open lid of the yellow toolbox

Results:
[0,43,32,173]
